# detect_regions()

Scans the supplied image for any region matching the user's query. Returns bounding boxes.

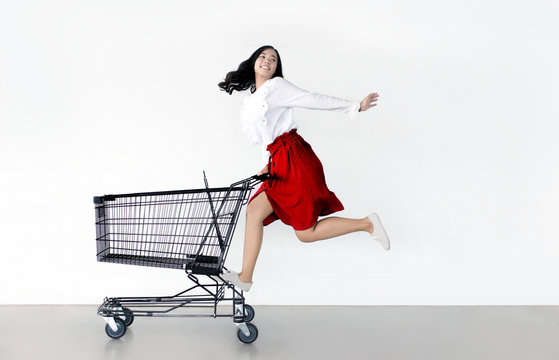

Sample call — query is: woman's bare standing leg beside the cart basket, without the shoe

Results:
[239,192,274,282]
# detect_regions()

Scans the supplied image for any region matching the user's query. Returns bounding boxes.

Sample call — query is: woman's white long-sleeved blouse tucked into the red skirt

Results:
[241,76,360,163]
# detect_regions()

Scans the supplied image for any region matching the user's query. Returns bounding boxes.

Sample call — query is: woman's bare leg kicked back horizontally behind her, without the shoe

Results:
[295,217,374,242]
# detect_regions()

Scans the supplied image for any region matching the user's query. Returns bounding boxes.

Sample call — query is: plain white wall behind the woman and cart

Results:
[0,0,559,304]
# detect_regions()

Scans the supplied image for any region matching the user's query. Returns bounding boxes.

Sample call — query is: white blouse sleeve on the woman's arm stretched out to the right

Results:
[268,77,360,118]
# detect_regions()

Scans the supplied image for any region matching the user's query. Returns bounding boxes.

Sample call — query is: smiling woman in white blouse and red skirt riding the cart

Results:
[218,45,390,291]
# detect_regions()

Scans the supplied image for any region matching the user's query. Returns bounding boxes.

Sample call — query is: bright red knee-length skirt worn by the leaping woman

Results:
[250,129,344,230]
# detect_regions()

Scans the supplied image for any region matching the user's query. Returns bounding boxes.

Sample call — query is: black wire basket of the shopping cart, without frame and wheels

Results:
[94,174,261,275]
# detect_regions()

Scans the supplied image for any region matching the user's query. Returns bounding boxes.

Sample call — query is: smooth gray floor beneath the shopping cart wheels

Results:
[0,306,559,360]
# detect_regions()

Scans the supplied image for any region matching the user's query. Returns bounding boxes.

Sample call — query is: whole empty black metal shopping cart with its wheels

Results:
[94,174,268,344]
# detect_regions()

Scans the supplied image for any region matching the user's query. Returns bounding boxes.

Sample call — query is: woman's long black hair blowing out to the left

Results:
[217,45,283,95]
